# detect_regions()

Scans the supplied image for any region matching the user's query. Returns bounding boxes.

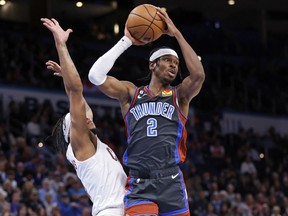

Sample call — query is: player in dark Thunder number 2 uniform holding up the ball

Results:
[88,8,205,216]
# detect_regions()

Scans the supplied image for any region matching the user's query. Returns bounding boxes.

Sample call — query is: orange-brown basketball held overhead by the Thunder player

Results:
[126,4,166,44]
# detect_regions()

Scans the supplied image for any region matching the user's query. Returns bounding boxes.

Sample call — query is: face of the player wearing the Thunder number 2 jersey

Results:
[155,55,179,84]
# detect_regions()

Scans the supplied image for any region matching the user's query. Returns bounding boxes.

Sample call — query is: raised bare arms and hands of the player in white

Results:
[41,18,95,160]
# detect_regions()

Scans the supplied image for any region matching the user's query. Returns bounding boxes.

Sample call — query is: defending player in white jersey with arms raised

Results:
[41,18,127,216]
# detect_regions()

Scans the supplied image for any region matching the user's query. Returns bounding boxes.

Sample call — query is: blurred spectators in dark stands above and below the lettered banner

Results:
[0,17,288,216]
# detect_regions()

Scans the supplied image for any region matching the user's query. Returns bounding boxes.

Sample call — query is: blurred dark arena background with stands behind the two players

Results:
[0,0,288,216]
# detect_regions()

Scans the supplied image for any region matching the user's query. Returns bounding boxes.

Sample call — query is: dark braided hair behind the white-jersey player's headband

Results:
[52,115,69,155]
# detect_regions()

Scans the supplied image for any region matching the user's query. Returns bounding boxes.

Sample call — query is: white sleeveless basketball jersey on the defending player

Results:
[66,139,127,216]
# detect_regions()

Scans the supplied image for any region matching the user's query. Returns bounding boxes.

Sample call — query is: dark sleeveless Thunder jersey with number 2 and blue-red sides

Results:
[123,86,187,170]
